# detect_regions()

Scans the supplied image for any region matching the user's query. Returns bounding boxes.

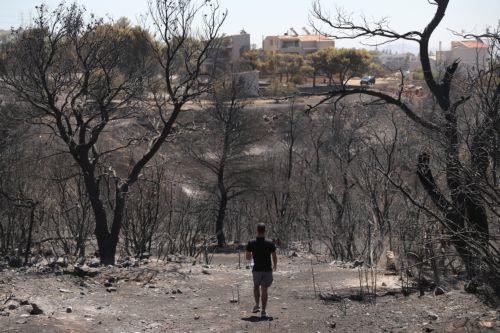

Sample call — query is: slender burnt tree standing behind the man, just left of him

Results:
[185,77,257,246]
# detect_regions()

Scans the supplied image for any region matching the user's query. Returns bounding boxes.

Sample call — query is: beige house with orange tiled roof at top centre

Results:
[262,28,335,55]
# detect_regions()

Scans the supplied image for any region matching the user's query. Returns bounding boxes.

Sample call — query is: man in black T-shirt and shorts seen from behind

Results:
[246,223,278,319]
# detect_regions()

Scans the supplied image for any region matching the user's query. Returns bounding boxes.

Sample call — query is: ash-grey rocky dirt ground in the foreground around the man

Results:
[0,254,500,333]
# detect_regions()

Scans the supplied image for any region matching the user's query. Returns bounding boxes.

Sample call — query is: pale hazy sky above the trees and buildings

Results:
[0,0,500,50]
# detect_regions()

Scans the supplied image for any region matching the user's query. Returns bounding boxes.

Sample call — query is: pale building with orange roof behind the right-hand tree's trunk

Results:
[436,38,490,68]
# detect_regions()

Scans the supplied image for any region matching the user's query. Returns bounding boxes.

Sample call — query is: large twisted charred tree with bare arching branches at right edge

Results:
[313,0,500,277]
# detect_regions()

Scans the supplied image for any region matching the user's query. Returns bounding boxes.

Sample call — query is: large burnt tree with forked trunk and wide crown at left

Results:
[0,0,226,264]
